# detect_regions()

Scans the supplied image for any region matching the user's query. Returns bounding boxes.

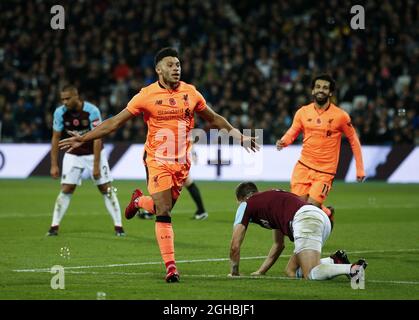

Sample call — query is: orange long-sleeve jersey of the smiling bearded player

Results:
[281,102,365,176]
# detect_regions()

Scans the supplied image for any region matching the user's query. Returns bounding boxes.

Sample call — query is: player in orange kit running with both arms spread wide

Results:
[59,48,259,282]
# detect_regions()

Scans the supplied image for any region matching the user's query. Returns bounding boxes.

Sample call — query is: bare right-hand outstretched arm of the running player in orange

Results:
[198,106,260,152]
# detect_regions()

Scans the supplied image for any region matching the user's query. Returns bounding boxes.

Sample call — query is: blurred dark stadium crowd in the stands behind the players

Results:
[0,0,419,144]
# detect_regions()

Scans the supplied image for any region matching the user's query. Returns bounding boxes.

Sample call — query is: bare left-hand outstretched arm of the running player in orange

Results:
[59,109,134,151]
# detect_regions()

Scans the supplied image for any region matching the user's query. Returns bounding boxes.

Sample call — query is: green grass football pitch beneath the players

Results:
[0,178,419,300]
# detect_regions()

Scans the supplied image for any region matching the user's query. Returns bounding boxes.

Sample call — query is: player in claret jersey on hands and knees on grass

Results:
[229,182,367,280]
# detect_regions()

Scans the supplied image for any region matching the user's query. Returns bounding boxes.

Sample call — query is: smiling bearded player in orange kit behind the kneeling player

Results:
[276,74,365,215]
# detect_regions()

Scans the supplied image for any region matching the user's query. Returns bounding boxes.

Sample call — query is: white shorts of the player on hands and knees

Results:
[292,205,331,254]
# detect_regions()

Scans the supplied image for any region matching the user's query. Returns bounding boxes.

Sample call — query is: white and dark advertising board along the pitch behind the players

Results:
[0,144,419,183]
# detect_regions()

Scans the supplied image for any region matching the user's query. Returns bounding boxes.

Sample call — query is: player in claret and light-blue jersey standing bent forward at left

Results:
[47,85,125,236]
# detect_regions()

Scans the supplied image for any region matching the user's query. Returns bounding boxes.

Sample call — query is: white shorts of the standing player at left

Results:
[61,150,113,186]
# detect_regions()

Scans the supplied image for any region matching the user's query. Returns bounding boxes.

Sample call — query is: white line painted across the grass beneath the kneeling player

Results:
[12,248,419,272]
